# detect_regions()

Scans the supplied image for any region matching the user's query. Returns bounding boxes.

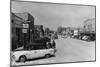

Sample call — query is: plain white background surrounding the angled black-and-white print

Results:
[0,0,100,67]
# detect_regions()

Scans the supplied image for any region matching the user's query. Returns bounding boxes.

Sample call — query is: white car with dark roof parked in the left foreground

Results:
[12,45,55,62]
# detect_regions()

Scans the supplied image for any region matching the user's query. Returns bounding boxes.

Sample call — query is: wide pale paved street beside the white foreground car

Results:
[12,38,95,65]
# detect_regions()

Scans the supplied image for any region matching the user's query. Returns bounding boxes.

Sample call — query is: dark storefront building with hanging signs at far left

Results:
[11,13,34,50]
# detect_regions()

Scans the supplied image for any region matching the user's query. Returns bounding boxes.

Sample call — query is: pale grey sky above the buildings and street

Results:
[11,1,95,30]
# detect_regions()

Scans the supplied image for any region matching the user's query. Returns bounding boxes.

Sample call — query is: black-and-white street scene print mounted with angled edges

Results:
[10,0,96,66]
